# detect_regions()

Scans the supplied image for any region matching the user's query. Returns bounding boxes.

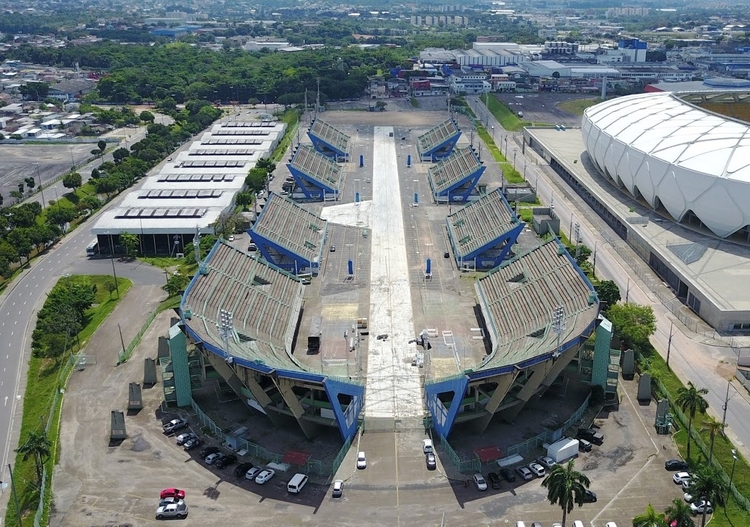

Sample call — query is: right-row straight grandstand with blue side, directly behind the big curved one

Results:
[446,189,523,269]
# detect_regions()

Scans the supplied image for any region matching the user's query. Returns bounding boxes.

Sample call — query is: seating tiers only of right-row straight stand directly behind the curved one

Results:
[448,189,519,258]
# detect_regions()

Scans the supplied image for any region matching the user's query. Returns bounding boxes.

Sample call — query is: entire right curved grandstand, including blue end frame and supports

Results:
[425,240,599,437]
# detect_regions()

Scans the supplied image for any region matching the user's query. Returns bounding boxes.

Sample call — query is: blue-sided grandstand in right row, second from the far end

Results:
[427,147,486,203]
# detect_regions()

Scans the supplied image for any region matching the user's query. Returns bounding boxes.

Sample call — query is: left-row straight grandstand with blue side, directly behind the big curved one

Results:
[250,193,327,274]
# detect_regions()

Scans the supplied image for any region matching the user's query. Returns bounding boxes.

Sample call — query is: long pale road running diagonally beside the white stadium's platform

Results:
[469,97,750,459]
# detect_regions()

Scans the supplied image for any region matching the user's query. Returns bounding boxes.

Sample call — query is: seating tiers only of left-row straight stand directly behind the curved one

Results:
[252,192,327,262]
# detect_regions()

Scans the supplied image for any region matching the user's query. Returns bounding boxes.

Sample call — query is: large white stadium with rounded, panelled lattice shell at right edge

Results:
[582,93,750,238]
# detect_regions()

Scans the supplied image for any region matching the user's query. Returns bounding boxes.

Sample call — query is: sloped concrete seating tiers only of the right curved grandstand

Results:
[476,240,599,369]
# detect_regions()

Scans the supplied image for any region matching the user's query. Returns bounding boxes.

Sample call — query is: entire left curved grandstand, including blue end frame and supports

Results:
[180,241,364,441]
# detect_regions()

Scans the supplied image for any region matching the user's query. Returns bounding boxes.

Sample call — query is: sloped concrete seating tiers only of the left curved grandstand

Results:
[181,241,306,370]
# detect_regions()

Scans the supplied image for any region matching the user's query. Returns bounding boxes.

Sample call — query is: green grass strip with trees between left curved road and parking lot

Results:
[5,275,132,526]
